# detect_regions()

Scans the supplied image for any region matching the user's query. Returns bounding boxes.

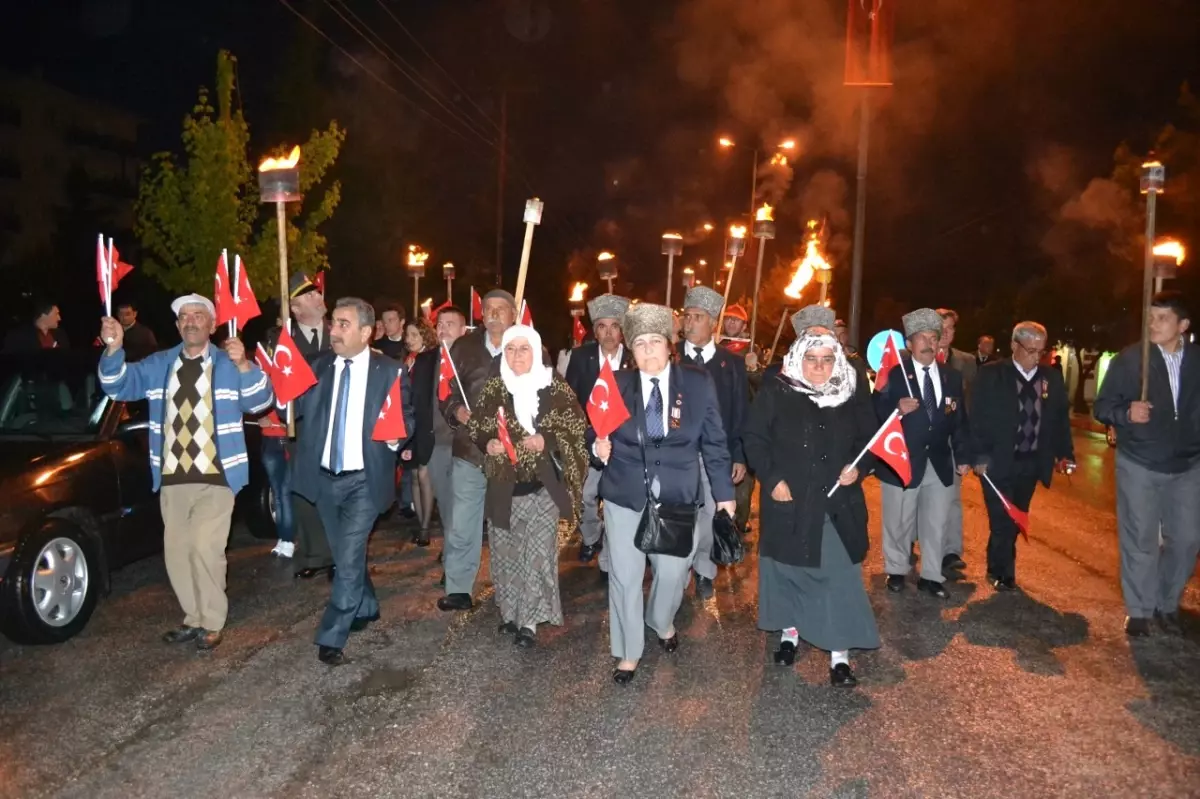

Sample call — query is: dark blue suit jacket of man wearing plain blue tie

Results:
[292,349,416,513]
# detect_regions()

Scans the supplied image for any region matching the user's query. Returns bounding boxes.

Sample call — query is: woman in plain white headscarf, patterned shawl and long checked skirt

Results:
[467,325,588,649]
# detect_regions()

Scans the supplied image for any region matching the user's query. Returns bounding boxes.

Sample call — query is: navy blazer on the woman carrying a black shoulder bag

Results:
[588,364,733,511]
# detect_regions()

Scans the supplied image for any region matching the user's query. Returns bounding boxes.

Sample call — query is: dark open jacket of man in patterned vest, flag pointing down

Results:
[971,359,1075,488]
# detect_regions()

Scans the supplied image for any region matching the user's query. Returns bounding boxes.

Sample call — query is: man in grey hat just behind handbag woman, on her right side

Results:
[678,286,750,599]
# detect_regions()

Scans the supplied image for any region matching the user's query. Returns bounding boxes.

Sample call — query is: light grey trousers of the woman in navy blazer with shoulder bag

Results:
[604,491,712,660]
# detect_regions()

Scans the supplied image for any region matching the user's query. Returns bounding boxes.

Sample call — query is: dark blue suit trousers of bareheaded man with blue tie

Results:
[316,471,379,649]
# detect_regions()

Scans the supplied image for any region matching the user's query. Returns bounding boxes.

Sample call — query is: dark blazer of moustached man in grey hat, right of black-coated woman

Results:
[875,359,971,487]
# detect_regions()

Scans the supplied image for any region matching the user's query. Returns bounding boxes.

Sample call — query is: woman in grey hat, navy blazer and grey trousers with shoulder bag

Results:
[589,302,736,685]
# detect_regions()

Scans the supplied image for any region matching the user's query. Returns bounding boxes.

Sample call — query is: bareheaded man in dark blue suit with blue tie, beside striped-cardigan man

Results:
[294,298,416,666]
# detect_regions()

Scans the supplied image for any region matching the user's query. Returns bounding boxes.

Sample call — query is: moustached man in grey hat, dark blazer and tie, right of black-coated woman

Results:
[876,308,970,599]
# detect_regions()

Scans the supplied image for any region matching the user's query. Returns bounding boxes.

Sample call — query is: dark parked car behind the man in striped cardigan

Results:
[0,350,275,643]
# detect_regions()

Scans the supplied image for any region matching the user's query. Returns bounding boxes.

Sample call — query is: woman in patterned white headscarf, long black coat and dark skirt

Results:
[742,331,880,687]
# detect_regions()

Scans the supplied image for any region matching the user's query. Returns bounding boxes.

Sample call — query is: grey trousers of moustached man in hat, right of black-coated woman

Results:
[880,463,961,583]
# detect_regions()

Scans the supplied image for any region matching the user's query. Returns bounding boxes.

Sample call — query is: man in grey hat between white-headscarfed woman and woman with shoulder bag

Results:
[565,294,635,559]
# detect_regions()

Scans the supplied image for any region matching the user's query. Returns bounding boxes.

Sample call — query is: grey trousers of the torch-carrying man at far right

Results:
[1116,450,1200,611]
